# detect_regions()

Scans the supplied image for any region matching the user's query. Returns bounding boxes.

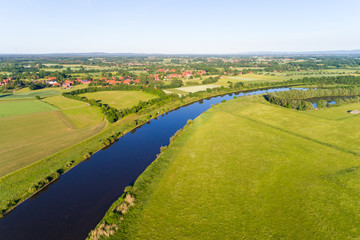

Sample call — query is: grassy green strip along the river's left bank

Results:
[0,84,306,218]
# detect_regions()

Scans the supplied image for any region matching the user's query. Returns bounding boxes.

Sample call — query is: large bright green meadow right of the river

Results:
[119,96,360,239]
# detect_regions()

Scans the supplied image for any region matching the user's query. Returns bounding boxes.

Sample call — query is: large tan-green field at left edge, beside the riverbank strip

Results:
[0,106,105,177]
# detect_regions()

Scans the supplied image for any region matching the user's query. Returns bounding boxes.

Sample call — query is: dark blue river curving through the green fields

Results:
[0,88,289,240]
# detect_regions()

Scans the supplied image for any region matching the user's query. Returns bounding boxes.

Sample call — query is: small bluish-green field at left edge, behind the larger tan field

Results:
[0,100,57,118]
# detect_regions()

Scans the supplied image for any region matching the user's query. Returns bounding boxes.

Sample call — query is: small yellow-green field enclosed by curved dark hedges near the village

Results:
[80,91,157,109]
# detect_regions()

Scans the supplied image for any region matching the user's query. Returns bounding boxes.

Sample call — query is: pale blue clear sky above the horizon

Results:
[0,0,360,54]
